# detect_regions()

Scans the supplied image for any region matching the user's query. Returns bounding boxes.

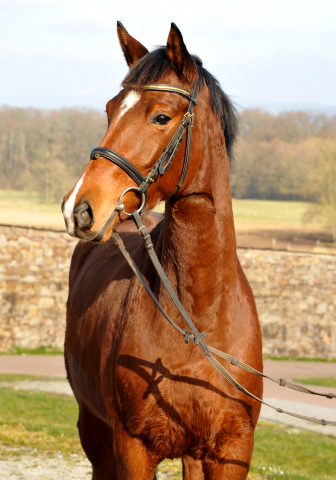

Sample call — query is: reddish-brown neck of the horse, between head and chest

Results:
[162,111,237,331]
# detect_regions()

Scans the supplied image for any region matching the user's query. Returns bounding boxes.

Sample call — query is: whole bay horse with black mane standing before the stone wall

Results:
[62,22,262,480]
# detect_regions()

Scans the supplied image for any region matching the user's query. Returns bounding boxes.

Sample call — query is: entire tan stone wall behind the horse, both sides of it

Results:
[0,227,336,358]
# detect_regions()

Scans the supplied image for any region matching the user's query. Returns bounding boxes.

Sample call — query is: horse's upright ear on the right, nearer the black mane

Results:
[166,23,198,81]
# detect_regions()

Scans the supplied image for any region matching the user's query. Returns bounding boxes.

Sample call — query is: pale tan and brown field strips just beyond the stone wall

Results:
[0,209,336,255]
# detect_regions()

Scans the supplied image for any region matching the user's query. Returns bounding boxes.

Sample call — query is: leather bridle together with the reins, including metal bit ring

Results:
[90,79,336,426]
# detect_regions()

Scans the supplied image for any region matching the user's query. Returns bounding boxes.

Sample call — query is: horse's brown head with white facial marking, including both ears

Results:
[62,22,201,243]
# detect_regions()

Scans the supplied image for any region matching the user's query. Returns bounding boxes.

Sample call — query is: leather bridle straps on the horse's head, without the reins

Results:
[90,79,198,214]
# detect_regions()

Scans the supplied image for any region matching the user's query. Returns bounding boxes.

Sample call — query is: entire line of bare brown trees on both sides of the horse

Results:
[0,107,336,238]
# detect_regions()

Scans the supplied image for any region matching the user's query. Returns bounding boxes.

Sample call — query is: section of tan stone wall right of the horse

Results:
[238,250,336,359]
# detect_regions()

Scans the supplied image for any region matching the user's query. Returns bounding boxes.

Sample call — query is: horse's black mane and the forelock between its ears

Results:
[124,47,238,160]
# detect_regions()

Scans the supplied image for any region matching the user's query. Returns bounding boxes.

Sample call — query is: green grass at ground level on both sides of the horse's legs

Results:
[0,376,336,480]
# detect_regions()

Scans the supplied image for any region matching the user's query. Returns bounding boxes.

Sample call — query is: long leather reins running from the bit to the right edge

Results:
[113,211,336,426]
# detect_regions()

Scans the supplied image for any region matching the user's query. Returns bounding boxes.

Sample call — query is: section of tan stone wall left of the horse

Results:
[0,227,77,351]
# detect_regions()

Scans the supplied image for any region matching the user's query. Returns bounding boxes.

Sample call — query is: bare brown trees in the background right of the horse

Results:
[231,109,336,237]
